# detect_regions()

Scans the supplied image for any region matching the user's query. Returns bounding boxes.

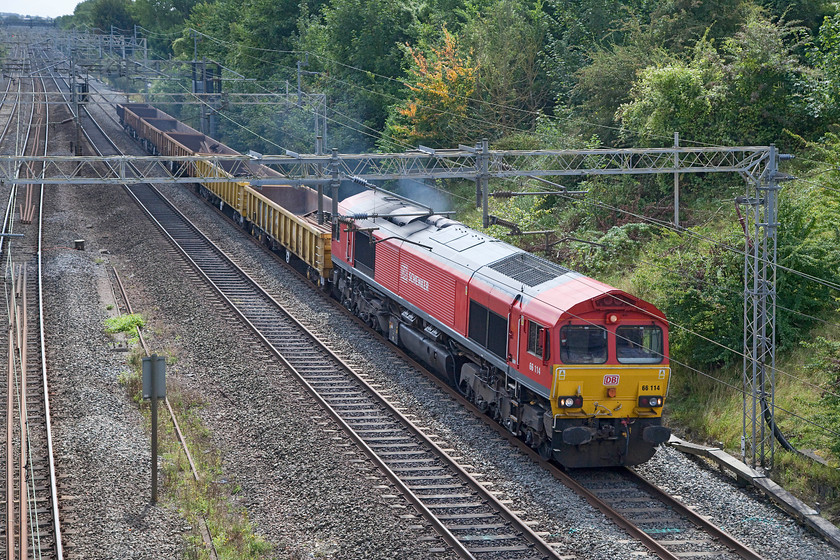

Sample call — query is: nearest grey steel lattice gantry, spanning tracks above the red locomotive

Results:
[0,143,788,468]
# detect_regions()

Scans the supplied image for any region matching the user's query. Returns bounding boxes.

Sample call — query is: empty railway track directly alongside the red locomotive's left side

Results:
[72,85,560,560]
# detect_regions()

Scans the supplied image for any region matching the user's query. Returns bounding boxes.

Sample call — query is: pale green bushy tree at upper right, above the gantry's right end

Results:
[616,12,812,145]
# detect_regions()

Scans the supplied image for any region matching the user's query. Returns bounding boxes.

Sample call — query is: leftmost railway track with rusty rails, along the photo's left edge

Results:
[0,46,63,559]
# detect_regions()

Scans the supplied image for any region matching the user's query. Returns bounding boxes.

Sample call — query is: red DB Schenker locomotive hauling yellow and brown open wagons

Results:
[117,104,670,468]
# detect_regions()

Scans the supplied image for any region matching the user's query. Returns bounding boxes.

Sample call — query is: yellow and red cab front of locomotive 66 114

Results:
[540,294,670,467]
